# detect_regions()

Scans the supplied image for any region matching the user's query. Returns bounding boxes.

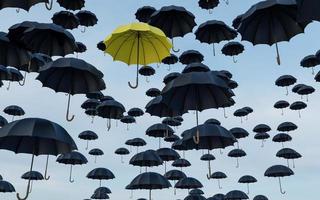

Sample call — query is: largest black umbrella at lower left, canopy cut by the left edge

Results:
[0,118,77,200]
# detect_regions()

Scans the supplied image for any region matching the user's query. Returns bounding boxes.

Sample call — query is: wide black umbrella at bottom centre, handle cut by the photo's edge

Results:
[126,172,171,200]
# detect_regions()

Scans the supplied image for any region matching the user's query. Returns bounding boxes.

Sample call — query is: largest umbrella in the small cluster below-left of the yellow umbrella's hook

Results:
[96,100,126,131]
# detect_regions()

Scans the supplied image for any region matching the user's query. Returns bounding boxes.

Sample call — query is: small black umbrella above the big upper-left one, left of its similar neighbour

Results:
[51,11,80,30]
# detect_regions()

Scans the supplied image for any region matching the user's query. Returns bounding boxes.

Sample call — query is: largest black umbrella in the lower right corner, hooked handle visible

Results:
[264,165,294,194]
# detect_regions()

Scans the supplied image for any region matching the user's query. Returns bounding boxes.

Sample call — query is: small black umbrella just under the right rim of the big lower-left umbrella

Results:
[57,151,88,183]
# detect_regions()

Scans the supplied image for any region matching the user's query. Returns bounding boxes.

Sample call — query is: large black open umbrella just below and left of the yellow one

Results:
[37,58,106,121]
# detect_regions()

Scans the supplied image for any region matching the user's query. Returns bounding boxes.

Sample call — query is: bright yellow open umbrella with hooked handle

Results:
[104,23,172,88]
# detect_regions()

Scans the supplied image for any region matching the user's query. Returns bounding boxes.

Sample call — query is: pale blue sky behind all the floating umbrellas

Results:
[0,0,320,200]
